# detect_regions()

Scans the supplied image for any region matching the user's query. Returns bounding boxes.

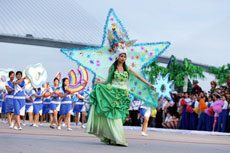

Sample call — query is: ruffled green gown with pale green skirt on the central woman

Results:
[86,66,131,146]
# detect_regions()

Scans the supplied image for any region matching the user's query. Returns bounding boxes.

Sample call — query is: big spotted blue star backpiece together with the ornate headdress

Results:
[61,9,170,107]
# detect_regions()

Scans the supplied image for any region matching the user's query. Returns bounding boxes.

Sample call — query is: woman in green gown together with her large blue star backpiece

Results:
[61,9,170,146]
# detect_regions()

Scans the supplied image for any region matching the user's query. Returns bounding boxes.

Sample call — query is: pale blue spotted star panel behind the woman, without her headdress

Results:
[61,9,170,106]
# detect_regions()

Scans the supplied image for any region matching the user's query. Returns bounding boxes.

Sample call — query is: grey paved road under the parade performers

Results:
[0,123,230,153]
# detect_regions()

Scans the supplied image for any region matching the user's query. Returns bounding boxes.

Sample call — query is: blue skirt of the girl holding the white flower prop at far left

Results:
[14,99,25,116]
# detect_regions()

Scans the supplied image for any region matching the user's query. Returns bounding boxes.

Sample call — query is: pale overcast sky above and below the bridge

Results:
[0,0,230,90]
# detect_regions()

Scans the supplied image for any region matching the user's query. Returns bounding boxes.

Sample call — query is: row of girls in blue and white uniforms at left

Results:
[0,71,87,131]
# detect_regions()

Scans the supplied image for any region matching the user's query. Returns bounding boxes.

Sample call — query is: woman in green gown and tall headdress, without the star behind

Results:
[86,21,159,146]
